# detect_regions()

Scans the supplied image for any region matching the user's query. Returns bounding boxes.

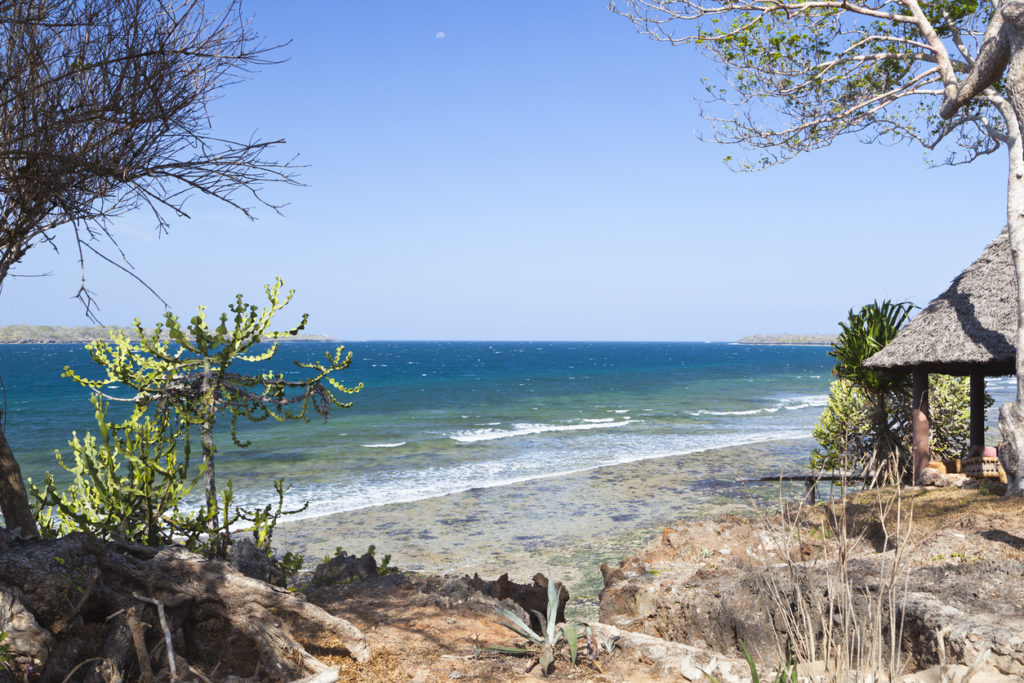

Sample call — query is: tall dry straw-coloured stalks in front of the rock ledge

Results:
[759,489,913,682]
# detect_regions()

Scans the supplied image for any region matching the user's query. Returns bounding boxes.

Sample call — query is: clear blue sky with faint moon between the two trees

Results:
[0,0,1006,341]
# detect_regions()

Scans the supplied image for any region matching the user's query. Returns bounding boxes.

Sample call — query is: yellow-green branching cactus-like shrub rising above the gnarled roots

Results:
[29,278,362,557]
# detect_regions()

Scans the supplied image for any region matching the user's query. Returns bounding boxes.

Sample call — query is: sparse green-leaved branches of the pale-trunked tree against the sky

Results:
[612,0,1017,170]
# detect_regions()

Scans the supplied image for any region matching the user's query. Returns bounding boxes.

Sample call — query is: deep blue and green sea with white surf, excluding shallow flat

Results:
[0,342,831,515]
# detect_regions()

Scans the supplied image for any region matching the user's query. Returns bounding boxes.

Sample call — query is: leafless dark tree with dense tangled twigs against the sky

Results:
[0,0,296,536]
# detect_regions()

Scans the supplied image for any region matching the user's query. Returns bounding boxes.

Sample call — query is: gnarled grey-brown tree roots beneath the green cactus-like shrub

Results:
[0,529,370,682]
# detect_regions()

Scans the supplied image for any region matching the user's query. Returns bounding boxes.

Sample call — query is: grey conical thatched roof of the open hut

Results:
[864,230,1017,376]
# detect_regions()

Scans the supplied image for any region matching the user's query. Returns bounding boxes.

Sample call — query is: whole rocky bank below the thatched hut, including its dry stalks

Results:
[601,483,1024,683]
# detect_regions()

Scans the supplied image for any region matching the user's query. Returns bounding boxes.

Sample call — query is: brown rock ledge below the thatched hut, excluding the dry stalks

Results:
[600,487,1024,680]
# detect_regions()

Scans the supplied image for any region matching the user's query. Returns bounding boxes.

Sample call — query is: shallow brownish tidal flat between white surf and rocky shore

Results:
[273,438,814,618]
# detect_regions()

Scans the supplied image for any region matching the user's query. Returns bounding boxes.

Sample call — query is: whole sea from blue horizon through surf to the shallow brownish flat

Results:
[6,342,1014,615]
